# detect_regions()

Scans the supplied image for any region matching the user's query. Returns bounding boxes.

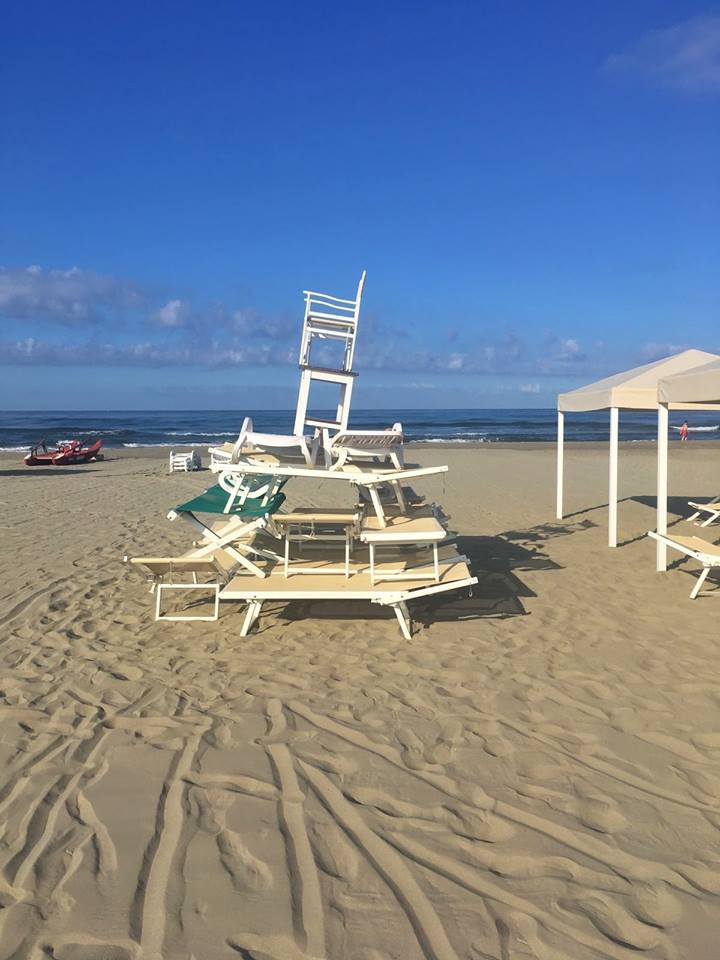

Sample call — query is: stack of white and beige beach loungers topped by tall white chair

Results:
[130,273,477,639]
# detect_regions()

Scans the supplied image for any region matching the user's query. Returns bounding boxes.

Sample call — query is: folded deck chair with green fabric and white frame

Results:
[168,483,285,577]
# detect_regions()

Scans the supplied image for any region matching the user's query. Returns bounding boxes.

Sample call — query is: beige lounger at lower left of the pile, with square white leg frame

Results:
[123,550,237,621]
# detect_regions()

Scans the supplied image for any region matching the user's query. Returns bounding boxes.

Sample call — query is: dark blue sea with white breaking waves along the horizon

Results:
[0,409,720,451]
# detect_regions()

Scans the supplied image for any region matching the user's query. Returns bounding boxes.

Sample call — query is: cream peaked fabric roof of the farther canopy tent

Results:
[558,350,720,413]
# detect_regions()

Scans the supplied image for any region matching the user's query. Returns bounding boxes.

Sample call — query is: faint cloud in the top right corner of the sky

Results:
[605,16,720,94]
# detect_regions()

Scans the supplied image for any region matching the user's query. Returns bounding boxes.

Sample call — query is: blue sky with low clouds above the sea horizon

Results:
[0,0,720,409]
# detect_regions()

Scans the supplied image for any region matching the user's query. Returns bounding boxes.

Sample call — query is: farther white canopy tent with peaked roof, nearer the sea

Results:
[556,350,720,547]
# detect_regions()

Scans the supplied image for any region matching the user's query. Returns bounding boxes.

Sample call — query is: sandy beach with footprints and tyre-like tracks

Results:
[0,443,720,960]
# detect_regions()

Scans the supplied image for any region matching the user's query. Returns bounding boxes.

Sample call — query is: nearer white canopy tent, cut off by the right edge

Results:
[656,358,720,570]
